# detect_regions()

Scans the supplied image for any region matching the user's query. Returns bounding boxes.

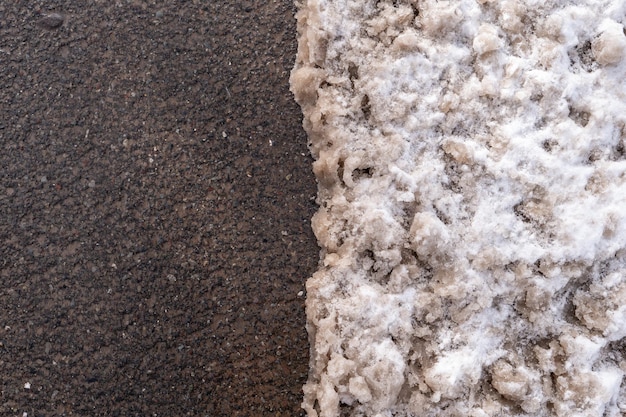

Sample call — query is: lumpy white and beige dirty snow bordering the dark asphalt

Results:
[291,0,626,417]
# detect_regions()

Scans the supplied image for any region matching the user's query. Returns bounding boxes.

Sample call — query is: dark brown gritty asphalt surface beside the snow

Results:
[0,0,318,416]
